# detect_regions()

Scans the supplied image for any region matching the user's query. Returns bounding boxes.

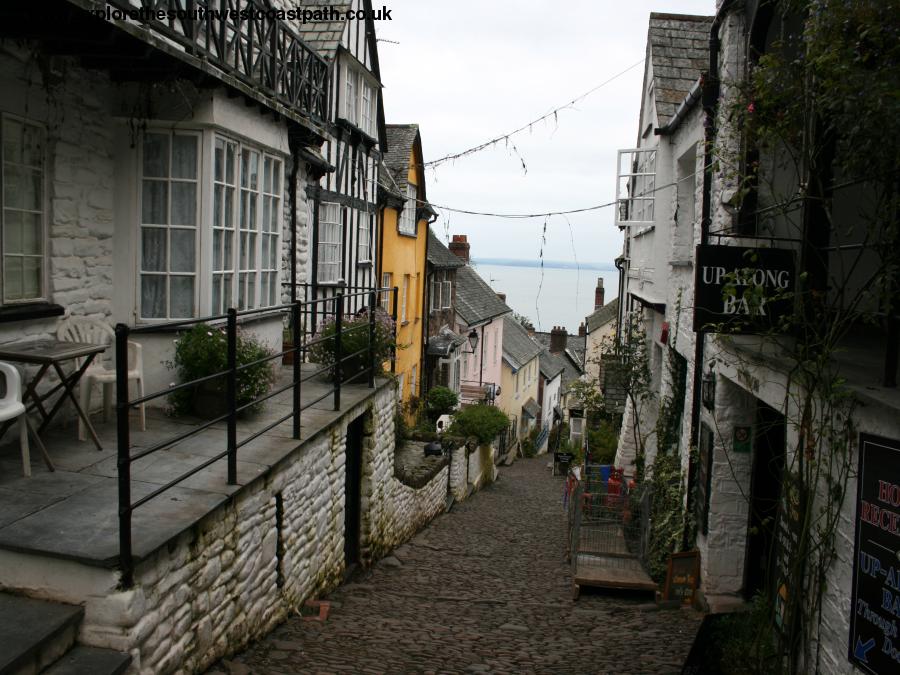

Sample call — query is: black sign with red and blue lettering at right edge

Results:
[848,434,900,675]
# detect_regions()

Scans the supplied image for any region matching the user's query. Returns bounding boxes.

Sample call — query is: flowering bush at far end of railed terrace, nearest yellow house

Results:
[309,307,396,382]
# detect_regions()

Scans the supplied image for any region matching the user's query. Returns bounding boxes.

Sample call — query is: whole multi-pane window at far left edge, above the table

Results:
[0,115,46,304]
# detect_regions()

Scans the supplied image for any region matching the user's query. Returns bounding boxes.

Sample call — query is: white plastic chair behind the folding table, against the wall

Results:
[56,317,147,441]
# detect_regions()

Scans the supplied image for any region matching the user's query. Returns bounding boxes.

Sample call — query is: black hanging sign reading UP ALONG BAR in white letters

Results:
[694,246,796,333]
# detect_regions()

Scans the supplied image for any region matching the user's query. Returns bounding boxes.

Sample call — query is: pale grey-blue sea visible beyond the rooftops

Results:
[473,260,619,334]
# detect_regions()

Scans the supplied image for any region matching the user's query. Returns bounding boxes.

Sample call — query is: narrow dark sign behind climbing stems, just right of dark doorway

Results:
[774,469,806,633]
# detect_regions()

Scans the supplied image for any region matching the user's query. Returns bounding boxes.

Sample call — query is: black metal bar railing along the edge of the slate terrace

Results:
[116,289,396,587]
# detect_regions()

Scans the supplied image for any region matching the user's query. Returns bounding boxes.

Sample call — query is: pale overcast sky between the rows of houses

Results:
[373,0,715,264]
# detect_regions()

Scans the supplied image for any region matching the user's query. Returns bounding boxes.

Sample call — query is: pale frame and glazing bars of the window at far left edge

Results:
[0,113,48,305]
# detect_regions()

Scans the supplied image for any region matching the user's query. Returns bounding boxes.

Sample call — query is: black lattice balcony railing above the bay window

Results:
[108,0,329,121]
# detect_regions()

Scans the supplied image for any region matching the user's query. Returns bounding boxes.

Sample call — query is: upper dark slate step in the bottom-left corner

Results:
[0,593,84,675]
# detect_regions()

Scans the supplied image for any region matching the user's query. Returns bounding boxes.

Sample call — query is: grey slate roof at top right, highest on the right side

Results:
[647,12,713,126]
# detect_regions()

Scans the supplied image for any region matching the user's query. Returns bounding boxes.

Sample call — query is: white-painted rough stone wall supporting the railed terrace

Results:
[74,384,494,675]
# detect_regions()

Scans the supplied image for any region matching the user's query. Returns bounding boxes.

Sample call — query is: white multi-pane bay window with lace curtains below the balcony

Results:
[138,131,283,319]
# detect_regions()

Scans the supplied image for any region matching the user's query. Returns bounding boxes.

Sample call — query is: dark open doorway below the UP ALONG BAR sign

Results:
[744,400,785,600]
